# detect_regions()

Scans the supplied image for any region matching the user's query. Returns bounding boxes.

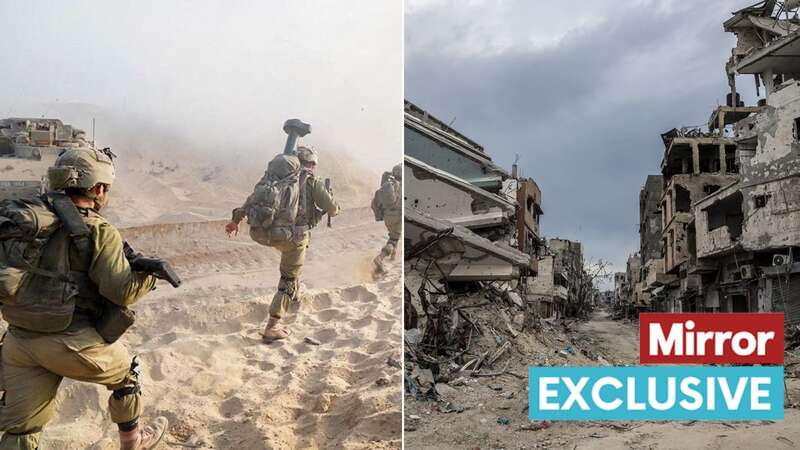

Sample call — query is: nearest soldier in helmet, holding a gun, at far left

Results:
[0,147,167,450]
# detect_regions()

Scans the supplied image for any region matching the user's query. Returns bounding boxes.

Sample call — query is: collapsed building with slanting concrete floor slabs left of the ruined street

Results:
[403,102,542,282]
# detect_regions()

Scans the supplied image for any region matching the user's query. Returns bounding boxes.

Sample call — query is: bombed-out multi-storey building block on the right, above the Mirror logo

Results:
[620,1,800,324]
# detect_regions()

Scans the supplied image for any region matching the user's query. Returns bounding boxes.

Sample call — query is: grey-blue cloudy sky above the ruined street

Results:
[405,0,755,282]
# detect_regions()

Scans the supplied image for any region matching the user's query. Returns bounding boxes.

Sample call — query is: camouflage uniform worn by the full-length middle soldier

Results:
[233,170,339,319]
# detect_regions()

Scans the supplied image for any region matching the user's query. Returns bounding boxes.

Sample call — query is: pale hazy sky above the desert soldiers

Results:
[0,0,402,168]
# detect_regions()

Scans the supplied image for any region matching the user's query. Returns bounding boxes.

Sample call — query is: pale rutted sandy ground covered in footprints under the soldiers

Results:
[37,210,401,449]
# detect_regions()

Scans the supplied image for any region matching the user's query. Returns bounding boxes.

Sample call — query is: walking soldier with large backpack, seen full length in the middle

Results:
[225,146,339,342]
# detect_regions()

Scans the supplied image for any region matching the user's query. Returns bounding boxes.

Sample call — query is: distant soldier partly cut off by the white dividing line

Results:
[372,164,403,278]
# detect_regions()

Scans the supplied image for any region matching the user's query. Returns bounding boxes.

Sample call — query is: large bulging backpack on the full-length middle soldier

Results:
[246,154,301,245]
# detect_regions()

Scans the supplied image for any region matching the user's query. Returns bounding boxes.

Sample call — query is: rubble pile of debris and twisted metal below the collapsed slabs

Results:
[404,279,618,413]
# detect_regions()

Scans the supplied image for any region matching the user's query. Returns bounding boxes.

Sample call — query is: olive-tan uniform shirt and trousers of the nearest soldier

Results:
[0,209,156,449]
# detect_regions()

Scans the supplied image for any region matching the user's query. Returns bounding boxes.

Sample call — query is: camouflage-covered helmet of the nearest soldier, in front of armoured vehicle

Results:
[47,147,114,191]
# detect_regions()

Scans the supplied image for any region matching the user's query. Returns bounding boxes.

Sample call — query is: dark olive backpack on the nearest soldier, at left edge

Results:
[0,193,101,333]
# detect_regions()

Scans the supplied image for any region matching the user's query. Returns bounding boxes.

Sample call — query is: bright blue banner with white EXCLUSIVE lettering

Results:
[528,365,784,420]
